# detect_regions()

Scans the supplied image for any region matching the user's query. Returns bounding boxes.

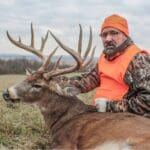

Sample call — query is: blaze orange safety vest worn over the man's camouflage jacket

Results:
[94,45,146,101]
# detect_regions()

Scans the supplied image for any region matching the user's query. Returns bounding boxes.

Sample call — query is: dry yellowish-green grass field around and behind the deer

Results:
[0,75,94,150]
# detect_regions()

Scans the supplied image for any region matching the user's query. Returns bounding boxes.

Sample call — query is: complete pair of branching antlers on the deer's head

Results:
[7,23,95,79]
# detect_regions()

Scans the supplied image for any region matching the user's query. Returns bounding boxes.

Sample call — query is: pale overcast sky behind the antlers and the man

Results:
[0,0,150,56]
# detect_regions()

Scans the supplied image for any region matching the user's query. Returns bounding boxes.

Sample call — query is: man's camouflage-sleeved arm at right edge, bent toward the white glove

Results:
[99,53,150,116]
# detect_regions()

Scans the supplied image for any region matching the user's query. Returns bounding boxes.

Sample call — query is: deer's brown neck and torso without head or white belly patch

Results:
[40,95,150,150]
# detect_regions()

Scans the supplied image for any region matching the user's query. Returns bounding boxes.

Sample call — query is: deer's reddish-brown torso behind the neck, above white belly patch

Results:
[48,113,150,150]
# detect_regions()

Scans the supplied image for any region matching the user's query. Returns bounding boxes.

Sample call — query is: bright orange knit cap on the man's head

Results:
[101,14,129,36]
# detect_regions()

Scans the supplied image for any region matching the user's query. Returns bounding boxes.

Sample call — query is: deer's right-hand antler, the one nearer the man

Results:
[45,24,96,78]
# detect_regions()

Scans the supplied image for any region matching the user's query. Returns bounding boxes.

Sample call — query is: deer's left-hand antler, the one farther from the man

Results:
[7,23,57,71]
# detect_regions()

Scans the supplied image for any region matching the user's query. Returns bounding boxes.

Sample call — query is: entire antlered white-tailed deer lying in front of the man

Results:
[3,25,150,150]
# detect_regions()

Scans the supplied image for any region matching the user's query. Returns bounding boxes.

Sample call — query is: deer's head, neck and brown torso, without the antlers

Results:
[5,76,150,150]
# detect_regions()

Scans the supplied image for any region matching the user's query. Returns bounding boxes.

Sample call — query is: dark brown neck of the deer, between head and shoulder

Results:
[39,93,96,133]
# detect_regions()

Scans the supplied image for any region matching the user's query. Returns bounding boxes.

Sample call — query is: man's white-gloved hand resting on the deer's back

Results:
[95,98,108,112]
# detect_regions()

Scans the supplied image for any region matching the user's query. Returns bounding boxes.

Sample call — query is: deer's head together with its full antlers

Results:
[3,24,95,102]
